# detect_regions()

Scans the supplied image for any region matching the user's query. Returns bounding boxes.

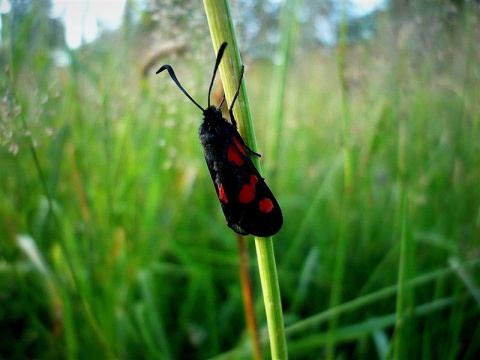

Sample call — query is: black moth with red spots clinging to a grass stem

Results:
[157,42,283,237]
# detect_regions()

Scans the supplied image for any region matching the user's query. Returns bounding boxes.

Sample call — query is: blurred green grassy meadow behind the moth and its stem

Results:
[0,0,480,359]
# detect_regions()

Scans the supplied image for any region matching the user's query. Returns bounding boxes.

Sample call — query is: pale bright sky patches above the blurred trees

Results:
[26,0,384,48]
